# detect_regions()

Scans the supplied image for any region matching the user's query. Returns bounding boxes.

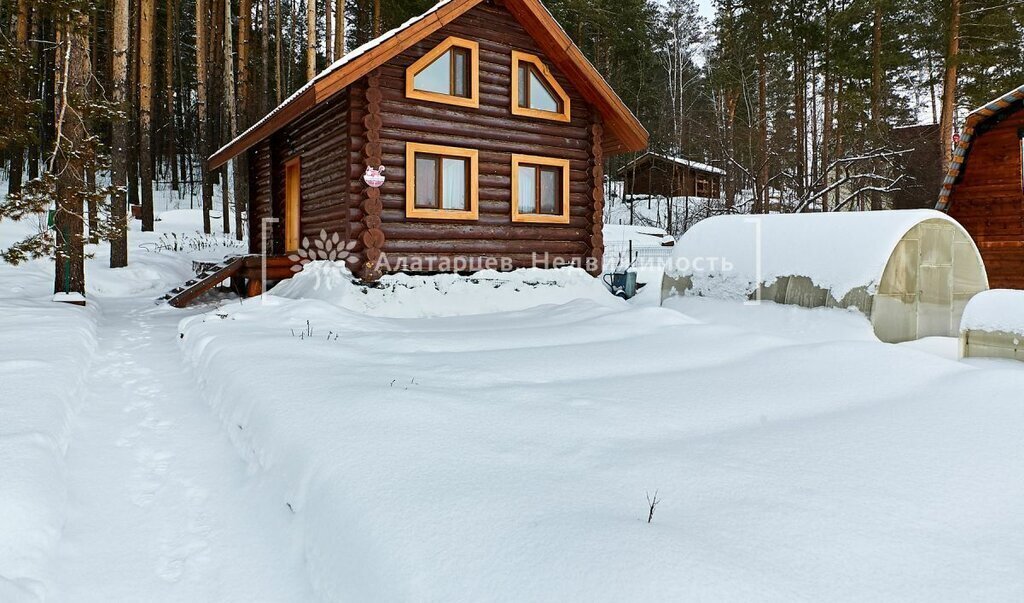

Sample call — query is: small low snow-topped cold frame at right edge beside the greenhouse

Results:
[961,289,1024,360]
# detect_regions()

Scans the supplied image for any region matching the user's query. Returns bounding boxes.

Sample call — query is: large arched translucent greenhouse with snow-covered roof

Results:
[662,210,988,343]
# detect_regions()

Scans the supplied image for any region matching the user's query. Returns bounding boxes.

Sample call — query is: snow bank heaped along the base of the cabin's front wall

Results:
[270,261,622,318]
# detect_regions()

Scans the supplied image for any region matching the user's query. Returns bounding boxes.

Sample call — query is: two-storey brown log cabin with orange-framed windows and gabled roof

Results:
[209,0,647,294]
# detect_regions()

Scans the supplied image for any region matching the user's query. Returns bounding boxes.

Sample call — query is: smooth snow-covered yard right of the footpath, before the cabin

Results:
[181,264,1024,601]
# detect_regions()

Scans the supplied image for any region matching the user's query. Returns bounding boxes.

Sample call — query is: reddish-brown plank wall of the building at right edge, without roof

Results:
[949,110,1024,289]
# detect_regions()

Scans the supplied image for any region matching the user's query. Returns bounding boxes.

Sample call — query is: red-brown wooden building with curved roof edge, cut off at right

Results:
[937,86,1024,289]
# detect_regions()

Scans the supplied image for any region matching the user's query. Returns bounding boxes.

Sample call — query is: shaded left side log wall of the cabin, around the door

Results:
[249,92,350,254]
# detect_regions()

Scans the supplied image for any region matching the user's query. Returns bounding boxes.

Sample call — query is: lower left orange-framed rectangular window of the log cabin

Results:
[406,142,478,220]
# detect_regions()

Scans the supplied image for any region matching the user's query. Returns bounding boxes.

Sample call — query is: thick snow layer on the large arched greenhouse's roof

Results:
[666,210,956,299]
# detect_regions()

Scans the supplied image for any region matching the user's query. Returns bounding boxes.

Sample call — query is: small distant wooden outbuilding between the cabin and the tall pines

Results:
[618,152,725,199]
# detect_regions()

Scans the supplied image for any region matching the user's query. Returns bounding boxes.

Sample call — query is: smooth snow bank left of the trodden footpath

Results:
[0,298,95,602]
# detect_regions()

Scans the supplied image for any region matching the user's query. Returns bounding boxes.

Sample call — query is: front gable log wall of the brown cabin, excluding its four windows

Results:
[372,4,599,266]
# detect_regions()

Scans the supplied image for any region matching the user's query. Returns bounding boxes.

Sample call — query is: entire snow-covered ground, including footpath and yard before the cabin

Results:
[0,193,1024,603]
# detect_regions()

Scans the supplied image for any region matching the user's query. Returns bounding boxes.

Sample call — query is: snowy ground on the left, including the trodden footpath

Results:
[0,204,312,603]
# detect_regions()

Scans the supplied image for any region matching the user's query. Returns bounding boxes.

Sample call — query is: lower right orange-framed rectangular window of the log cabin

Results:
[512,155,569,223]
